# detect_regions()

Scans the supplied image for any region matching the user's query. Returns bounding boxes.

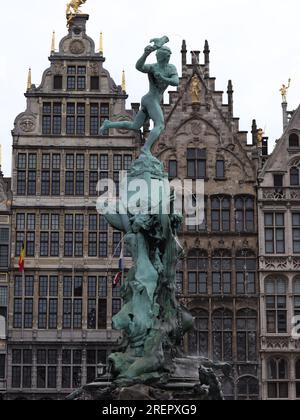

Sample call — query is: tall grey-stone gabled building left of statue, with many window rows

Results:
[7,15,140,399]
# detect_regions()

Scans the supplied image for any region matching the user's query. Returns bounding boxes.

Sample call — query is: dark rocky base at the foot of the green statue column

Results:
[68,357,231,401]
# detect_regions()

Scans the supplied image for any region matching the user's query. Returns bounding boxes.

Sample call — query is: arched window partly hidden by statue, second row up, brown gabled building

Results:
[189,310,209,357]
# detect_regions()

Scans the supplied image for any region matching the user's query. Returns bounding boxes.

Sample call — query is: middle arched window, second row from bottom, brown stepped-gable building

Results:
[213,309,233,362]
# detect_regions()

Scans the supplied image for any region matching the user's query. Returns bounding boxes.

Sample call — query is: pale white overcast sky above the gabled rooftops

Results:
[0,0,300,176]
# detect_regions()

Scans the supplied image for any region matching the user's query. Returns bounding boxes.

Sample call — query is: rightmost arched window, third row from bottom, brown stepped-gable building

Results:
[235,249,257,295]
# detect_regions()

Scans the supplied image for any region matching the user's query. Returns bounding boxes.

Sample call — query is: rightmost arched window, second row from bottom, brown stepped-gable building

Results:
[237,309,257,362]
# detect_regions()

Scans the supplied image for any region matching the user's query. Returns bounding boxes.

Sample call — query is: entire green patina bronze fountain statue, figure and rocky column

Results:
[98,37,193,385]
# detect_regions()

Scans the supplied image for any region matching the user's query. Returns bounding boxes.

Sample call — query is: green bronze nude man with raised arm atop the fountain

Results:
[100,37,179,155]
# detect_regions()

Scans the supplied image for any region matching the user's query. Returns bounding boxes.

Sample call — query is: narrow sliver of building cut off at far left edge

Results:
[0,170,11,400]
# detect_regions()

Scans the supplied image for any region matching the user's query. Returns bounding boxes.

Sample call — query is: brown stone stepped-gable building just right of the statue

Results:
[155,42,260,399]
